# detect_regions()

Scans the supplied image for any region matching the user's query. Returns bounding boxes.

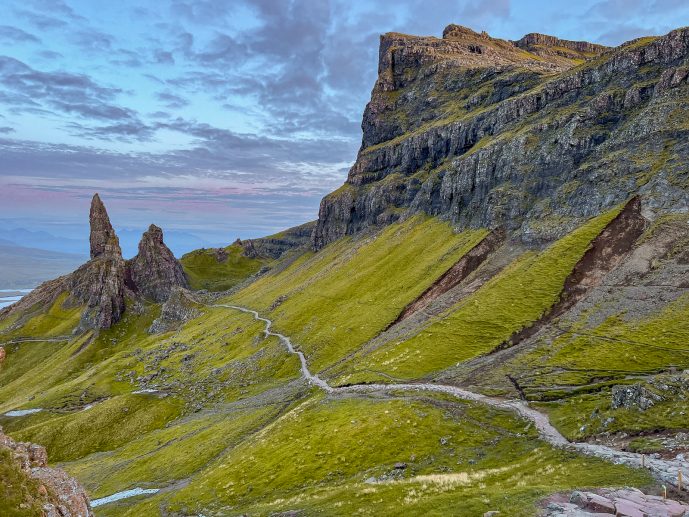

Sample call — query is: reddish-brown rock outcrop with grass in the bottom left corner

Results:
[0,427,93,517]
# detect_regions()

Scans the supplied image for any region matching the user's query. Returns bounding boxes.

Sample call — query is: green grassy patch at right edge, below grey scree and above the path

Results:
[512,295,689,439]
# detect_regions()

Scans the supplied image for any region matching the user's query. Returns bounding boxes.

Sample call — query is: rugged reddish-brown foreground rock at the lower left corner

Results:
[0,427,93,517]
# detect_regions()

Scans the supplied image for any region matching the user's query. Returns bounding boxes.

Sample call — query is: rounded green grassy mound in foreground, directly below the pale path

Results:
[106,396,649,516]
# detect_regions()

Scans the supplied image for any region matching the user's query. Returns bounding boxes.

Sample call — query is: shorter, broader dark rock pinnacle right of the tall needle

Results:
[127,224,189,302]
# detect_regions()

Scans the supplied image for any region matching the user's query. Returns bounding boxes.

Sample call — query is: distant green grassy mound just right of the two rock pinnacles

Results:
[180,244,269,291]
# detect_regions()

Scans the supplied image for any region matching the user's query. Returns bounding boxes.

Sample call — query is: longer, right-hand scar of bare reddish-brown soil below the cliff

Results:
[491,196,647,353]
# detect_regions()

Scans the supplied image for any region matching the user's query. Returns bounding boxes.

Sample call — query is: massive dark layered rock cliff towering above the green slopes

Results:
[312,25,689,249]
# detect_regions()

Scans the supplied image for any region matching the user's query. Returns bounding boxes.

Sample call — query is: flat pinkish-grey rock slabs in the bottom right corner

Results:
[542,488,689,517]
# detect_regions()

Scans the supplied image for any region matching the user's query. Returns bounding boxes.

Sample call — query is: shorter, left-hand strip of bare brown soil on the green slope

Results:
[385,230,505,330]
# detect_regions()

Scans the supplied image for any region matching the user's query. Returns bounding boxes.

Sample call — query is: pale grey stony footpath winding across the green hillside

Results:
[211,304,689,490]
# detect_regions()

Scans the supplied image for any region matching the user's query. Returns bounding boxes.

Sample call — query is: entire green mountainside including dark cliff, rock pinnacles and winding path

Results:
[0,25,689,517]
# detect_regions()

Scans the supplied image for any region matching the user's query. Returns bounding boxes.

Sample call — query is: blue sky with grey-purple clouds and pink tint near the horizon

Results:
[0,0,689,255]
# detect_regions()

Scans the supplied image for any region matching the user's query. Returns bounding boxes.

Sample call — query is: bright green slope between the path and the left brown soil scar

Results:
[231,217,486,371]
